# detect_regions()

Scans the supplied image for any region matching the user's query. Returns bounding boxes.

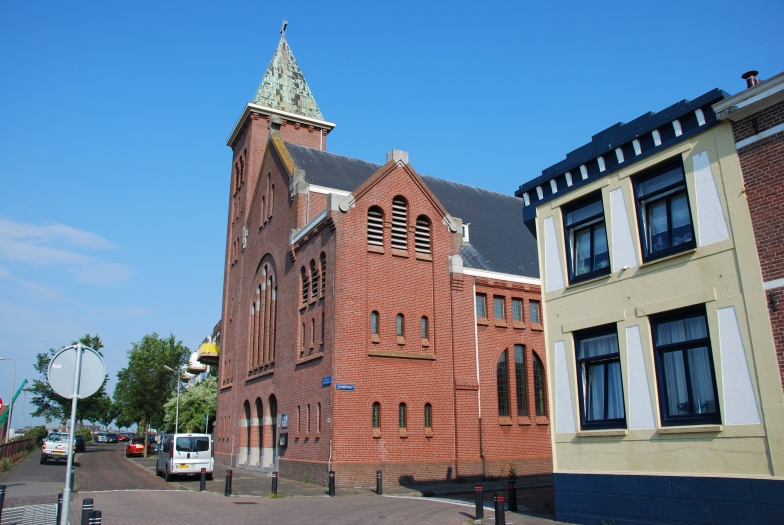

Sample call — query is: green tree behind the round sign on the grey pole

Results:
[25,334,111,425]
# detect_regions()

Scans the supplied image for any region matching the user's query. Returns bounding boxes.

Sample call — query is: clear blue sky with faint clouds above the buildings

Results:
[0,0,784,426]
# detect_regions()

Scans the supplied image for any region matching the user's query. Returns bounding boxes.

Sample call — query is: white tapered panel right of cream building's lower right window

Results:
[719,306,762,425]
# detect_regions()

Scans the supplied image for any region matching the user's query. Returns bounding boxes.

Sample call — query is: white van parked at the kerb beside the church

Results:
[155,434,215,481]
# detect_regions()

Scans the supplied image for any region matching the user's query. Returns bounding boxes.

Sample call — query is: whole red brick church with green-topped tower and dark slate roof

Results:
[215,29,552,486]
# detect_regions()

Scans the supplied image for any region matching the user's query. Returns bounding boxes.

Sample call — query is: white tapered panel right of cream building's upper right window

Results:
[692,151,730,246]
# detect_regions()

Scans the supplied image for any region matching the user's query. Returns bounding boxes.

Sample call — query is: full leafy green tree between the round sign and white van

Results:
[114,333,190,456]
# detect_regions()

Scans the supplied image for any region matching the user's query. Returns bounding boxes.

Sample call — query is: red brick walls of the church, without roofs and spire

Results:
[215,111,552,486]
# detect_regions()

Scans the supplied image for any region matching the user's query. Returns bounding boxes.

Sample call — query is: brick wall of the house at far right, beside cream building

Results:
[732,98,784,385]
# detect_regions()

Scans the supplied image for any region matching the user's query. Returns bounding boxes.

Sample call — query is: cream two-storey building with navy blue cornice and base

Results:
[516,90,784,523]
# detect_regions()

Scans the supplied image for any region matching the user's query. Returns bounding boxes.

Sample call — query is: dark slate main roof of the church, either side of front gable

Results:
[286,143,539,278]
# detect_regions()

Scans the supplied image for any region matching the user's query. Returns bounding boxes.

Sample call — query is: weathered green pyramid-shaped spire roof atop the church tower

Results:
[251,36,324,120]
